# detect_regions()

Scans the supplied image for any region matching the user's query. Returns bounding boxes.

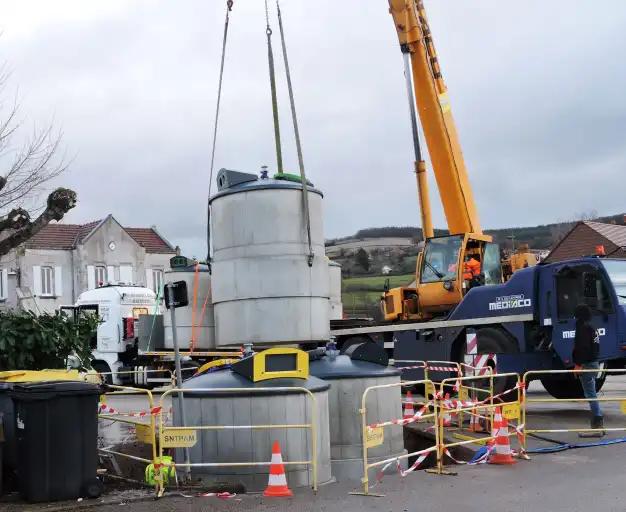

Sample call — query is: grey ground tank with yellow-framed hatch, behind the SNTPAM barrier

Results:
[173,370,331,491]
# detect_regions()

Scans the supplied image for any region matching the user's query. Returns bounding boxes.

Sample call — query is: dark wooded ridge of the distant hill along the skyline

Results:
[326,213,624,249]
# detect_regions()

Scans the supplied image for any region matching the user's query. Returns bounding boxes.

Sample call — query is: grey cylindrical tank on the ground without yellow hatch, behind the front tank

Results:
[309,355,406,481]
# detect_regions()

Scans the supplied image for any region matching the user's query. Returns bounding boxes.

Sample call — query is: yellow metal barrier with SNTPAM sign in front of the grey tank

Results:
[155,387,319,496]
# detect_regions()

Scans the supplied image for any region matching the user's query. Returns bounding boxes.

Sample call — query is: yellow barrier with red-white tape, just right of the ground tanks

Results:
[350,379,439,496]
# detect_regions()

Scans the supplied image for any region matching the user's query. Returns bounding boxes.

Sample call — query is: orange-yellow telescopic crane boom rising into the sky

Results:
[389,0,482,236]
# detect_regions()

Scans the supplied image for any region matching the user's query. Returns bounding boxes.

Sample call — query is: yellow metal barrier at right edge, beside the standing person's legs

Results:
[522,368,626,450]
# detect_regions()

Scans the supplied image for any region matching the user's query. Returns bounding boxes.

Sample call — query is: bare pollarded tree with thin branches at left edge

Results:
[0,65,76,256]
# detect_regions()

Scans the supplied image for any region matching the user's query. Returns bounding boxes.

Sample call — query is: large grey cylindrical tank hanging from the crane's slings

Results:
[210,169,330,346]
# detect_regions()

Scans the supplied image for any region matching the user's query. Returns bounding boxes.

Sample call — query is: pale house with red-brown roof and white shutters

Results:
[0,215,176,312]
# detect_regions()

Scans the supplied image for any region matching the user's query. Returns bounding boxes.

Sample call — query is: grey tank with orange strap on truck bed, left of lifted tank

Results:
[163,265,215,350]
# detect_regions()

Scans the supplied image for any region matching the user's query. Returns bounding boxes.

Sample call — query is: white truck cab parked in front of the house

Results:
[61,284,162,384]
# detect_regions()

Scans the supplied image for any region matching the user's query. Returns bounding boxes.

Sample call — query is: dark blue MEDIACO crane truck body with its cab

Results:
[332,257,626,398]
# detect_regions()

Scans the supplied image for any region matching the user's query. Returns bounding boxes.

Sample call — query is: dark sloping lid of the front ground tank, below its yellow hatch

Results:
[174,370,330,397]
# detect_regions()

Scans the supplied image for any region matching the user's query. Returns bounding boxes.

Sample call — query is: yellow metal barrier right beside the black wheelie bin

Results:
[98,384,161,490]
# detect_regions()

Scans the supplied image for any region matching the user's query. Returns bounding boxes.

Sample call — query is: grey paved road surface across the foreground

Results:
[6,377,626,512]
